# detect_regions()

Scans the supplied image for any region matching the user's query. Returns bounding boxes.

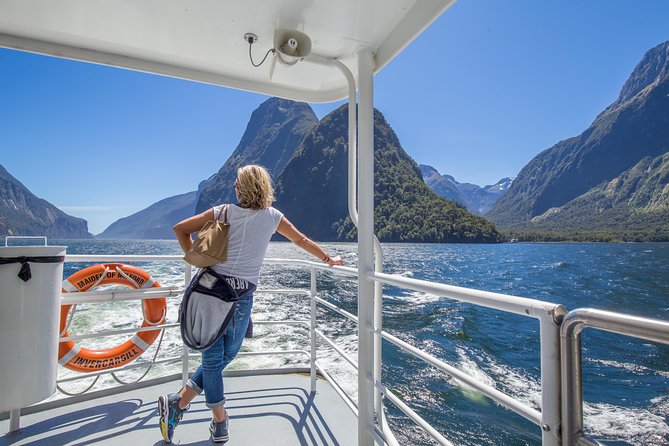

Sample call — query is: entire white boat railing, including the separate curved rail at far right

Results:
[27,255,669,446]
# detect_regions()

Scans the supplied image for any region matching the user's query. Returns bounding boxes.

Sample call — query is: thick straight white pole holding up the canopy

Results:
[358,48,374,446]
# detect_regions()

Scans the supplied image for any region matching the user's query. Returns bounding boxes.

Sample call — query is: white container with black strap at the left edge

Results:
[0,246,66,412]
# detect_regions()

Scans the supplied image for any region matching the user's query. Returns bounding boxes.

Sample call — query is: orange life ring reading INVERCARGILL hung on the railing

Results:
[58,263,167,372]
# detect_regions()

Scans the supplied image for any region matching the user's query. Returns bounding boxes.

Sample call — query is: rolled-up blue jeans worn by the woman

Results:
[186,293,253,409]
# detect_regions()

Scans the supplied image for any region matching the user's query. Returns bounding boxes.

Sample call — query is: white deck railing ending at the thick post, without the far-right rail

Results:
[51,255,566,445]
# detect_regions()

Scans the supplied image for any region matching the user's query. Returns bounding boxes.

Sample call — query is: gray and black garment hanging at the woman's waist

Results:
[179,268,255,351]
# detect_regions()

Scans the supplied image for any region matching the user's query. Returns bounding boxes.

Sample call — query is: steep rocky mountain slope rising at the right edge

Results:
[488,42,669,237]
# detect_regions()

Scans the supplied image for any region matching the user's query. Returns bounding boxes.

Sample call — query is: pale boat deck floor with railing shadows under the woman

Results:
[0,373,357,446]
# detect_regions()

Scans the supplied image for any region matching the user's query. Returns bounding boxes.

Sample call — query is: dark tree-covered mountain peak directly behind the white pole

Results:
[276,105,499,242]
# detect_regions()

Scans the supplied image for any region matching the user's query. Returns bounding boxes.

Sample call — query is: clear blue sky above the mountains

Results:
[0,0,669,233]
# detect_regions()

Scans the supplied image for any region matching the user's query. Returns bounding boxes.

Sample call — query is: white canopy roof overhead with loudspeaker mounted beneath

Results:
[0,0,454,102]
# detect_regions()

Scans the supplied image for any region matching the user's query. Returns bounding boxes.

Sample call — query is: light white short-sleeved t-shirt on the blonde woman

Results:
[211,204,283,285]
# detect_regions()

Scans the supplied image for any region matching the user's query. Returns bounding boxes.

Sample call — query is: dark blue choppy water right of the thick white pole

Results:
[376,244,669,445]
